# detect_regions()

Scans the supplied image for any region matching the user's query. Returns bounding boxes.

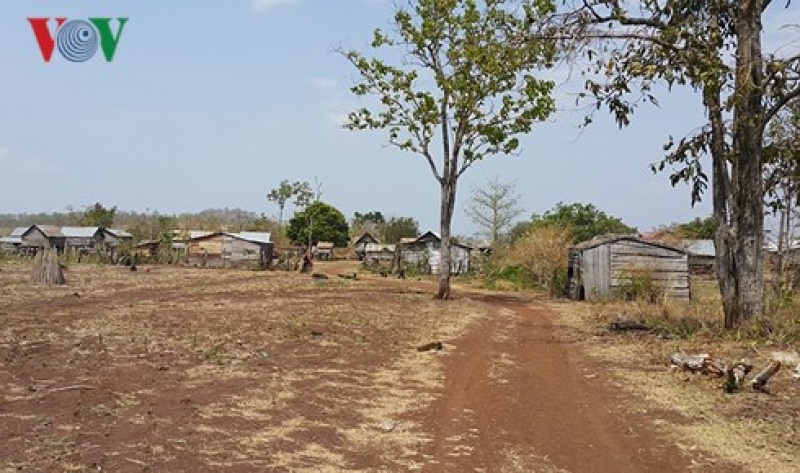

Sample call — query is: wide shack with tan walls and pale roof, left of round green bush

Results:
[186,232,274,269]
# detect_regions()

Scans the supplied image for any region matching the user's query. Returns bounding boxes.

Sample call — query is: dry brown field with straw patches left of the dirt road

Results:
[0,265,482,471]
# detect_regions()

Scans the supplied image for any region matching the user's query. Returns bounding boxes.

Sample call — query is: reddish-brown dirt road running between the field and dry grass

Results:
[412,296,738,472]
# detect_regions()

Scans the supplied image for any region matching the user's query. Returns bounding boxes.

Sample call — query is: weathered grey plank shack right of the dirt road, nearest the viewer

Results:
[567,235,690,300]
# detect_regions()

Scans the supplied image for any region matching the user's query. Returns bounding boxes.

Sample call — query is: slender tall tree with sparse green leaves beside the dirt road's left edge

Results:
[341,0,555,299]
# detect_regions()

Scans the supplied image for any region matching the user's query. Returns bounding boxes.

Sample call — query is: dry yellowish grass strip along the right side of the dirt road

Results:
[551,283,800,472]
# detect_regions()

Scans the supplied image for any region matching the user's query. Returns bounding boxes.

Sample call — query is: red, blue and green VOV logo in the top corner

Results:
[28,18,128,62]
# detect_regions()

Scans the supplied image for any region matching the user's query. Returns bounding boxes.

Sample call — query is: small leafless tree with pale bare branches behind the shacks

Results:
[464,176,524,248]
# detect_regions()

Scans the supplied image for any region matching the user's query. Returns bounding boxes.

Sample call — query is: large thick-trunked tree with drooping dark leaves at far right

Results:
[552,0,800,328]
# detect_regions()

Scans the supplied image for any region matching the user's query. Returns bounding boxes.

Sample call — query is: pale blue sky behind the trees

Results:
[0,0,800,234]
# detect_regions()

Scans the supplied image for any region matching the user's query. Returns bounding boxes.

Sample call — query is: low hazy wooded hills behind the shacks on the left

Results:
[0,208,277,240]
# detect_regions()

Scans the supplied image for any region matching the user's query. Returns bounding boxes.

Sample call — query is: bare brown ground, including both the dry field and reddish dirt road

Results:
[0,265,797,472]
